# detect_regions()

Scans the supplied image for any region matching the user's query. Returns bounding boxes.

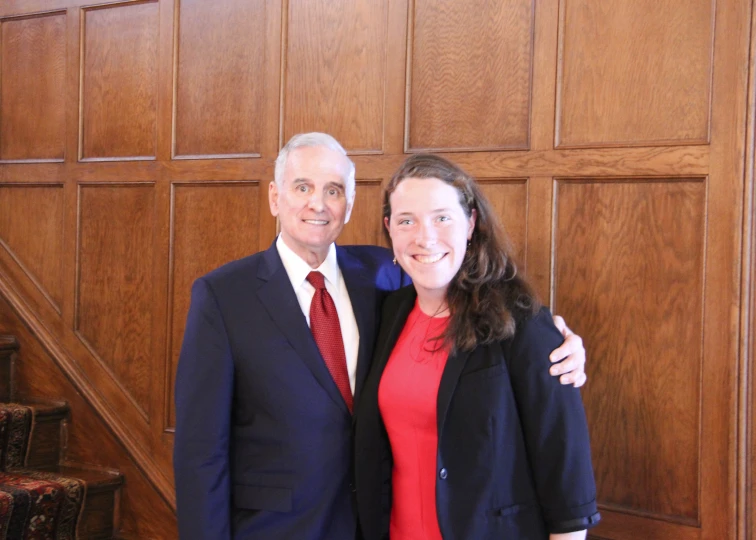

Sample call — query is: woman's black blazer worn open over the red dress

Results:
[355,286,600,540]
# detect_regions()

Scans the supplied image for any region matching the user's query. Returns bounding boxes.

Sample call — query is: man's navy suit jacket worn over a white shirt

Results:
[174,243,409,540]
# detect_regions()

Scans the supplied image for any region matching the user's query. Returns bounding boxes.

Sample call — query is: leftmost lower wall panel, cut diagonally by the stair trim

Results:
[0,184,63,311]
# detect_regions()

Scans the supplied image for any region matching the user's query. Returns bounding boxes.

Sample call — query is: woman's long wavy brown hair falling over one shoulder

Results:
[383,154,540,353]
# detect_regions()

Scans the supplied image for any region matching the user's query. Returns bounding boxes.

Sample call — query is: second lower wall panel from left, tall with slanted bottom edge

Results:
[75,184,155,418]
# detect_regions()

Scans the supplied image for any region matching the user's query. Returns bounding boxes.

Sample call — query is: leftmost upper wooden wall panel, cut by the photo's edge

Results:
[0,13,66,160]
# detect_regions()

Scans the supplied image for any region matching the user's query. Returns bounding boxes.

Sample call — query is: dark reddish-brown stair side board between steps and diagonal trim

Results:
[0,295,178,540]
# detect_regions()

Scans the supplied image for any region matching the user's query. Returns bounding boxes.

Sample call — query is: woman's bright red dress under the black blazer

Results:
[378,301,449,540]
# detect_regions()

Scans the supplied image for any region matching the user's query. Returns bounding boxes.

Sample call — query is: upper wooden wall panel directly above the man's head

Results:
[282,0,390,153]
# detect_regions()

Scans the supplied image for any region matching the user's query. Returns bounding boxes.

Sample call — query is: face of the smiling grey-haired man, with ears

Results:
[268,146,353,264]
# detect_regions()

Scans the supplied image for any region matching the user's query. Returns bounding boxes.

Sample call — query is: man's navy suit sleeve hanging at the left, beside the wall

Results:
[173,278,234,540]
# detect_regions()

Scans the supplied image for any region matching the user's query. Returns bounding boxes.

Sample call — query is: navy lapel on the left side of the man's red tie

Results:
[257,243,349,413]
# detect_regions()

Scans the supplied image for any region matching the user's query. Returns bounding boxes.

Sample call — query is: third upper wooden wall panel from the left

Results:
[174,0,268,156]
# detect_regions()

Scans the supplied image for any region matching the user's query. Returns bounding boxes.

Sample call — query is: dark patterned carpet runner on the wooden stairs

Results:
[0,403,86,540]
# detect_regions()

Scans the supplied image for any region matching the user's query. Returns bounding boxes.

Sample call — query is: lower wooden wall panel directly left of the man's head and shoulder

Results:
[166,181,267,427]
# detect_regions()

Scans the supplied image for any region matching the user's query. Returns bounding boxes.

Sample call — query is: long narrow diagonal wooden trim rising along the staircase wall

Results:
[0,270,176,511]
